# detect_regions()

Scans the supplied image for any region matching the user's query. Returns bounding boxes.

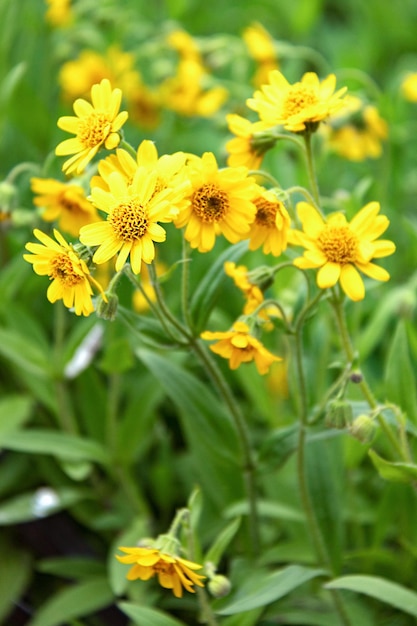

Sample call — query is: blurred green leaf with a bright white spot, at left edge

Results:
[0,487,91,526]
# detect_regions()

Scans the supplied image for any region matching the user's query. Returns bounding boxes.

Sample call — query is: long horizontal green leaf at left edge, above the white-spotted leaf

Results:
[0,428,109,464]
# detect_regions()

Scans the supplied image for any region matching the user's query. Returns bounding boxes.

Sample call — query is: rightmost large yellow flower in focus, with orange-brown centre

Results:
[290,202,395,301]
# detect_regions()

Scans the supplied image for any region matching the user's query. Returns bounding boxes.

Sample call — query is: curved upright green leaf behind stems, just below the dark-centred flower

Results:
[190,241,248,331]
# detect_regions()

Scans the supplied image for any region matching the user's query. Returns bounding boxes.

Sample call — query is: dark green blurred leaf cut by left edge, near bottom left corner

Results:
[0,536,31,624]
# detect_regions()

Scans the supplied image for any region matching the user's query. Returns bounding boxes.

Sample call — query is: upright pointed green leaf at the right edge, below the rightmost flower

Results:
[385,319,417,424]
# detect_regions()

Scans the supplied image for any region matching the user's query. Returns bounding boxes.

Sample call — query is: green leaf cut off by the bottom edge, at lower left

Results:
[28,578,113,626]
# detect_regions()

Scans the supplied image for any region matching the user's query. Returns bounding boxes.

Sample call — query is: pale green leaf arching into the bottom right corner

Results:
[324,575,417,617]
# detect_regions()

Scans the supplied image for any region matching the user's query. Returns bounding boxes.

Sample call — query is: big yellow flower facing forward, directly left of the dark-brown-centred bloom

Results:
[80,167,183,274]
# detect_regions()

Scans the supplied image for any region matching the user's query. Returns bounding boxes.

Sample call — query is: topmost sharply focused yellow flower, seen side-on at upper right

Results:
[247,70,346,133]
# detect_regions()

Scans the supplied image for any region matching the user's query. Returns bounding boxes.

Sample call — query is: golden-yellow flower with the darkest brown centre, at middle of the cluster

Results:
[175,152,259,252]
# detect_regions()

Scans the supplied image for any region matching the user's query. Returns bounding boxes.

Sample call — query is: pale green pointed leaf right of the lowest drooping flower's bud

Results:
[216,565,325,615]
